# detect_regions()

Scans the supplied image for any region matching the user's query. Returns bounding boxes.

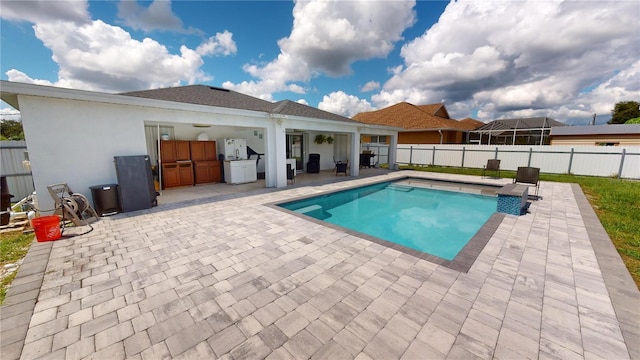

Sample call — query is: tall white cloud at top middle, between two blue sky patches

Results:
[224,0,415,100]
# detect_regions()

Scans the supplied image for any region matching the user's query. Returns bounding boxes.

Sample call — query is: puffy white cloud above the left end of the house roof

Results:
[9,20,210,91]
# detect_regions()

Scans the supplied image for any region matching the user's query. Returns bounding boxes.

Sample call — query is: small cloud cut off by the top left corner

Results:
[0,0,91,24]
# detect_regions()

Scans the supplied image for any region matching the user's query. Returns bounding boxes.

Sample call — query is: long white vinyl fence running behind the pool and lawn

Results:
[397,144,640,179]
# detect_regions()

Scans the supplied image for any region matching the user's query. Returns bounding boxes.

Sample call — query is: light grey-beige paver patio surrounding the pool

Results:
[0,171,640,360]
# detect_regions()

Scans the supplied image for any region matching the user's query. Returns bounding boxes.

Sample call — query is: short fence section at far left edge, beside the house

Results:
[0,141,34,202]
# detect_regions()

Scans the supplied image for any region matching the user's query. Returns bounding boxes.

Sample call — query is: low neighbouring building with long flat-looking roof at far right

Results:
[551,124,640,146]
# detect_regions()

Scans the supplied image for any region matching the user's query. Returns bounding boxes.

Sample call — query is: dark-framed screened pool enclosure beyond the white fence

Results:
[468,117,566,145]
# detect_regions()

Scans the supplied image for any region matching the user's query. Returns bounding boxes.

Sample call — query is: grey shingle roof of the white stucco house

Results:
[120,85,357,123]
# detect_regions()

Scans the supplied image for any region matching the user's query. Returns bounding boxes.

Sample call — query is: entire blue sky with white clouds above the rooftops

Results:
[0,0,640,125]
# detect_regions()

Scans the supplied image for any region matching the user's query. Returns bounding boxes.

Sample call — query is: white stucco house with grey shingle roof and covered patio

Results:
[0,81,398,209]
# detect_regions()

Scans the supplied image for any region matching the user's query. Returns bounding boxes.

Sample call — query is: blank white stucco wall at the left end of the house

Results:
[19,96,147,214]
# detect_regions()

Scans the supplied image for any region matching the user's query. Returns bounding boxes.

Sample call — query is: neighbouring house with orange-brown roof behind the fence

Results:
[353,102,484,144]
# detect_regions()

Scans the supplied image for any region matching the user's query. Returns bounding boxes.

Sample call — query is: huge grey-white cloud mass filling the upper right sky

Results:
[372,0,640,120]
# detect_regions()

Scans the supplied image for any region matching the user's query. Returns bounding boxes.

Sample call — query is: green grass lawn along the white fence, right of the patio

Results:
[402,166,640,288]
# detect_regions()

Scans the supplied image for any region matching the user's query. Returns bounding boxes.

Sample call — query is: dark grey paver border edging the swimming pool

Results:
[264,175,506,273]
